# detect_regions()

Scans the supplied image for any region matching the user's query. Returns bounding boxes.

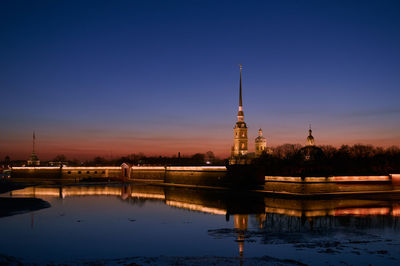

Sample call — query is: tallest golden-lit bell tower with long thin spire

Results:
[231,65,248,159]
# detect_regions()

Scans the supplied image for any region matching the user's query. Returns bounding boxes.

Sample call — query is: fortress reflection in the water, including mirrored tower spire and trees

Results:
[11,185,400,256]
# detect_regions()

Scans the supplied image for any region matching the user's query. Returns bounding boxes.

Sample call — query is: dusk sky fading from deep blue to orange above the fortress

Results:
[0,0,400,160]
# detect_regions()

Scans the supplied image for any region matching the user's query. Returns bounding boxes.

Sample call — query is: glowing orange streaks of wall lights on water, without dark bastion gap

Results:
[10,186,400,217]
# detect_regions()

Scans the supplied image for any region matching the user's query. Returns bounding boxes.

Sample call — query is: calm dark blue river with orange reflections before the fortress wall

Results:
[0,185,400,265]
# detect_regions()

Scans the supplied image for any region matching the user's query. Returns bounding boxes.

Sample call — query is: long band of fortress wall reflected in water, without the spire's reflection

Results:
[10,185,400,220]
